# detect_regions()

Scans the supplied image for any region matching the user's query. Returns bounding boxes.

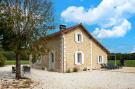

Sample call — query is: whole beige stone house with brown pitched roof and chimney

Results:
[32,24,109,72]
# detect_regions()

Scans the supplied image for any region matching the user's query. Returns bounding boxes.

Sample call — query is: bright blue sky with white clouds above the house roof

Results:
[53,0,135,53]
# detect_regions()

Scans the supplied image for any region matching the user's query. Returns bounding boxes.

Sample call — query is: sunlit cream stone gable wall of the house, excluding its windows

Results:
[64,28,107,70]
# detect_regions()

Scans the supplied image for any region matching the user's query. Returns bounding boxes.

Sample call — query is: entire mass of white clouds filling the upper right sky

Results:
[61,0,135,38]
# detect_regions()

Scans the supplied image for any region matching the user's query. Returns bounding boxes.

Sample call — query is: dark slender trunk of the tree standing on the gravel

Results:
[16,51,21,80]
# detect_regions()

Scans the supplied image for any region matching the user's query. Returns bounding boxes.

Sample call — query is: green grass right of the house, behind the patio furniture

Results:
[108,60,135,67]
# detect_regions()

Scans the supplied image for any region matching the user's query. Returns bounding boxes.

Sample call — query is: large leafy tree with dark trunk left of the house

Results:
[0,0,54,79]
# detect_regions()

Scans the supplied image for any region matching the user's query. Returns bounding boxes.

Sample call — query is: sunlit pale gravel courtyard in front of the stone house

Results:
[0,67,135,89]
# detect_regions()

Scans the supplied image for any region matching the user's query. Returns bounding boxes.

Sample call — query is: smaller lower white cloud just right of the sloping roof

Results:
[93,19,131,38]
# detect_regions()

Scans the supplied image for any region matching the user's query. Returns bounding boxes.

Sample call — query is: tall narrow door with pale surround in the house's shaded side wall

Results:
[49,51,55,70]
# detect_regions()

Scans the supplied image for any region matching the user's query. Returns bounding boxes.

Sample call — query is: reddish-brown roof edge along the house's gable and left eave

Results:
[47,23,110,54]
